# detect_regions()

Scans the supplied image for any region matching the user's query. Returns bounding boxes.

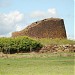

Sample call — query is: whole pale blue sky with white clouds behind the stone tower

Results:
[0,0,75,39]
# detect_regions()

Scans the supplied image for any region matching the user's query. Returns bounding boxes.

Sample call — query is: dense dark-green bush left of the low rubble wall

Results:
[0,36,42,53]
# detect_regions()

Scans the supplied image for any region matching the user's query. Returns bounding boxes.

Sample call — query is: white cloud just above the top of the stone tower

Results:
[30,8,58,19]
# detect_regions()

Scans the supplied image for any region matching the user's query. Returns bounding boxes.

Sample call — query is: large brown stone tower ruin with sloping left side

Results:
[12,18,67,38]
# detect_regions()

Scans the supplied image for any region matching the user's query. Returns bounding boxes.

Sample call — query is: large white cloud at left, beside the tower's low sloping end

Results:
[0,11,24,36]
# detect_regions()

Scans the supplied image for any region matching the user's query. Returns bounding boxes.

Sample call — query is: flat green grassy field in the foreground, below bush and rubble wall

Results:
[0,53,75,75]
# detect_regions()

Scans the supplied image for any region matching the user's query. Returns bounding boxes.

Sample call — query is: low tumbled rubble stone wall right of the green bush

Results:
[40,44,75,53]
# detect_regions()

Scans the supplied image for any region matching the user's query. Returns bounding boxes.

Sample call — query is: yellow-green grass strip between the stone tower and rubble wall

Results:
[37,38,75,45]
